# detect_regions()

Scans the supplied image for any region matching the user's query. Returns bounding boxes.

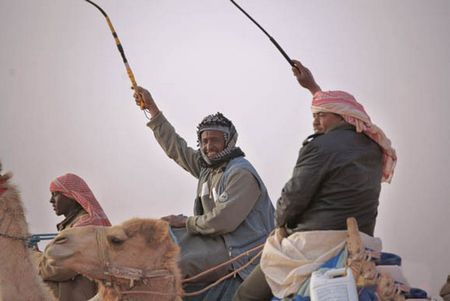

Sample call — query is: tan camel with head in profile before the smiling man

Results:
[45,218,182,301]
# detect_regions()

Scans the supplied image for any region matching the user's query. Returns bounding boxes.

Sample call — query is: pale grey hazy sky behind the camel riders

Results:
[0,0,450,296]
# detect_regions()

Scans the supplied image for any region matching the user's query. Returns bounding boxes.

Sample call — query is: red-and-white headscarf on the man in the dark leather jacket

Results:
[311,91,397,183]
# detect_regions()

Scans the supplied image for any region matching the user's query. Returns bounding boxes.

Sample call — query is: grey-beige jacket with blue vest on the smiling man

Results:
[148,113,274,279]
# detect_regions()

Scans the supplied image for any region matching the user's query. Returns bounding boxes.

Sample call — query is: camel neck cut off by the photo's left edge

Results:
[0,165,56,301]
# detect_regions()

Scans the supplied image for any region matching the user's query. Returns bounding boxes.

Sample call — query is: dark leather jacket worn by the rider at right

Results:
[276,123,382,235]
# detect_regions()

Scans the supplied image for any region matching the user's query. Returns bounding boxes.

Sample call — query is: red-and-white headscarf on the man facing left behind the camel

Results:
[50,173,111,227]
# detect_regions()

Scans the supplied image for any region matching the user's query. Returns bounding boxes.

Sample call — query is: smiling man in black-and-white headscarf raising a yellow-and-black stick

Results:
[135,87,274,301]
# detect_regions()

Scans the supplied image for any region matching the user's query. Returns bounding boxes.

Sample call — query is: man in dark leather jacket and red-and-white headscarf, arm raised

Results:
[233,61,397,301]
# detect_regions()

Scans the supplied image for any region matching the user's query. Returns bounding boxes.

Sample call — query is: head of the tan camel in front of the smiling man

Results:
[45,218,179,281]
